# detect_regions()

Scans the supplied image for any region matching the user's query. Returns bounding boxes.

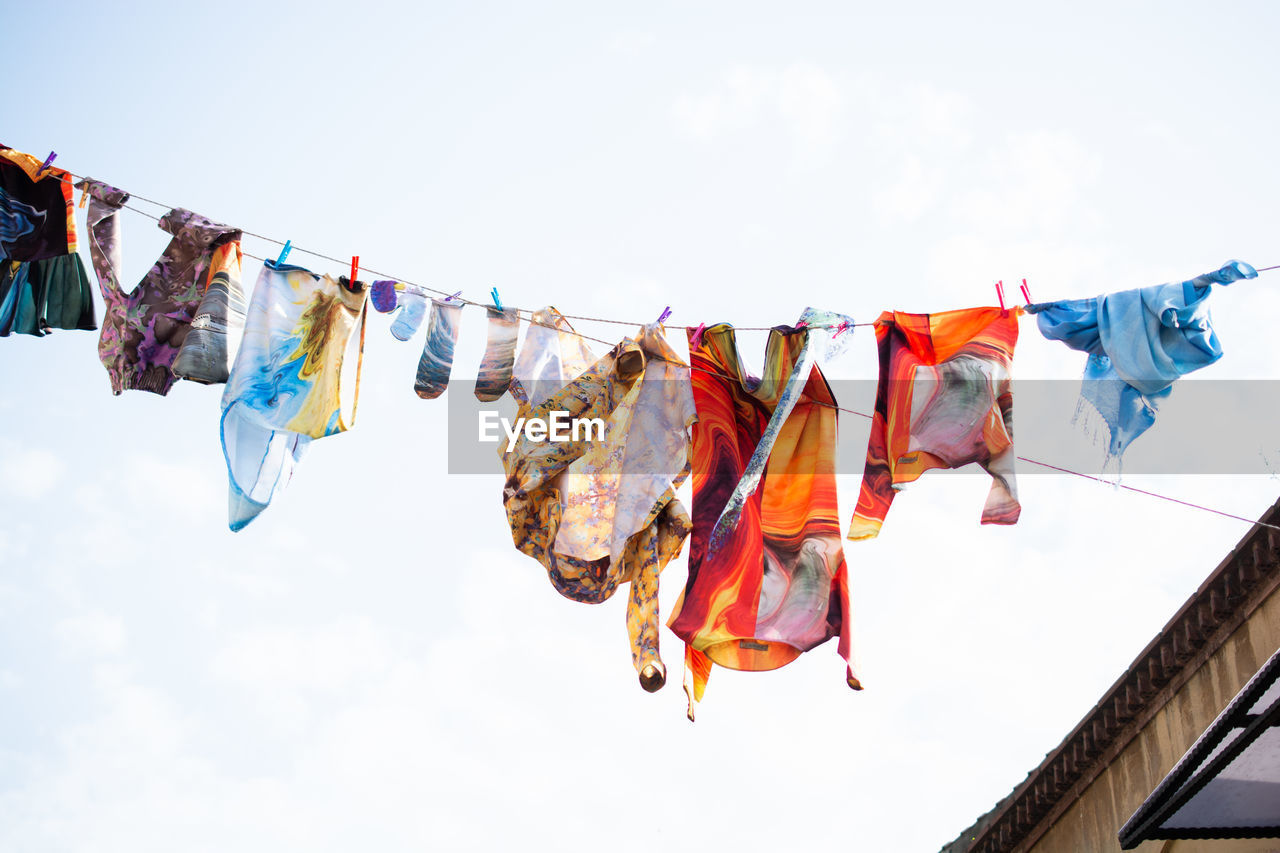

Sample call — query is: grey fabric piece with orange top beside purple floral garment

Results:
[173,240,246,384]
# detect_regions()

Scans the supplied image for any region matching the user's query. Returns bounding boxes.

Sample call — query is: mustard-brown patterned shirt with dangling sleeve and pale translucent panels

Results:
[502,309,694,692]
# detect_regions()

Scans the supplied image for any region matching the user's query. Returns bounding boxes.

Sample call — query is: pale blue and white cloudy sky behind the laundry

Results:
[0,0,1280,853]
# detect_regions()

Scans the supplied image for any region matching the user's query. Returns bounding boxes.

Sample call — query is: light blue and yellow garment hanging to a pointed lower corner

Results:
[220,260,367,530]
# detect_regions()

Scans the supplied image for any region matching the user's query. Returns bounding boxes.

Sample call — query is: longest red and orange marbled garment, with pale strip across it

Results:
[668,310,861,720]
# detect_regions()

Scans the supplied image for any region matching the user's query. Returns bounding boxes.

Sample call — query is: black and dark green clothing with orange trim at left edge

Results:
[0,146,97,337]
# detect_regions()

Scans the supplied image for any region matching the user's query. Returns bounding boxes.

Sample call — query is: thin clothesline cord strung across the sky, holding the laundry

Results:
[37,162,1280,530]
